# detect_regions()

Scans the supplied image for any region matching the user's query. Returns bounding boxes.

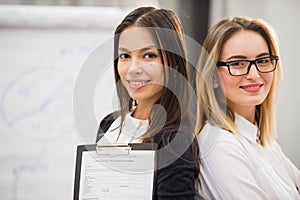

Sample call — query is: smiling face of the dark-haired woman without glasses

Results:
[118,26,164,105]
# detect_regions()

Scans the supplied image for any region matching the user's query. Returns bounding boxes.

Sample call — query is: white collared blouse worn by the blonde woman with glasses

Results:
[198,116,300,200]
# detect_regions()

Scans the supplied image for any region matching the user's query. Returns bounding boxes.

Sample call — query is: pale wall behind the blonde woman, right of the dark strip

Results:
[210,0,300,168]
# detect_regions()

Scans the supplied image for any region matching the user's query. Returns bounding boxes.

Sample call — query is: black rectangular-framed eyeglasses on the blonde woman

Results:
[217,56,279,76]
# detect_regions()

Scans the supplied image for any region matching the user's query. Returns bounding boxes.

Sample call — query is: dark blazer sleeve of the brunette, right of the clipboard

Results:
[153,133,198,200]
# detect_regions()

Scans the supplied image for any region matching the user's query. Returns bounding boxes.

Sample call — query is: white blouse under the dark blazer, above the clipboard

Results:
[98,113,148,144]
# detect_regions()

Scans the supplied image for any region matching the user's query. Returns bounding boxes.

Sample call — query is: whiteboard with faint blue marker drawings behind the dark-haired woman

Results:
[0,6,128,200]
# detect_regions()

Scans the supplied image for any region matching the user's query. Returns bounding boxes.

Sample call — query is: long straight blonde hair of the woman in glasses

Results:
[196,17,282,146]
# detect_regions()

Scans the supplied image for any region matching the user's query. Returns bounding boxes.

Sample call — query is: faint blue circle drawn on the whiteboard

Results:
[0,67,73,140]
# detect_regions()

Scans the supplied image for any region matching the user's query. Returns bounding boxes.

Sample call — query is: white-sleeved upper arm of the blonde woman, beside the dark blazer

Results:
[201,136,268,200]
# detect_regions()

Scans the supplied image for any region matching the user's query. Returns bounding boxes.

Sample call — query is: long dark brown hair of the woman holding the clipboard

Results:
[114,7,199,177]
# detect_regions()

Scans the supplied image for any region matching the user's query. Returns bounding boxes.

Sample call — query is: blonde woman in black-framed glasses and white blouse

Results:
[196,17,300,200]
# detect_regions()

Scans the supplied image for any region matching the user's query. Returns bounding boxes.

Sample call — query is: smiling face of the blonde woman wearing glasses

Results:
[218,30,273,117]
